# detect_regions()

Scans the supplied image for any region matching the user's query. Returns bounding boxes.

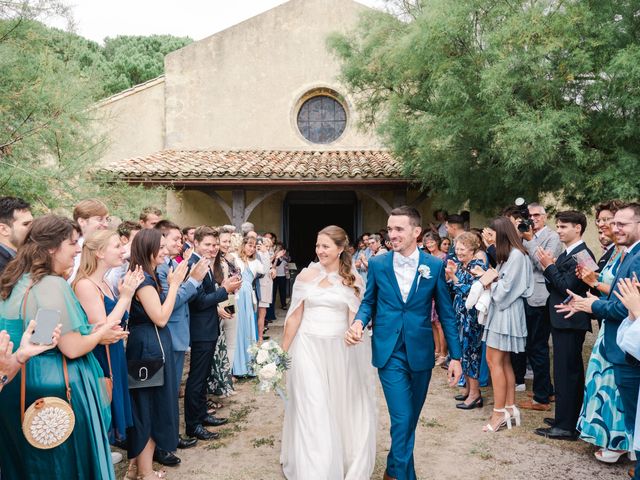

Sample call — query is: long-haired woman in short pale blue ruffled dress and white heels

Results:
[480,217,534,432]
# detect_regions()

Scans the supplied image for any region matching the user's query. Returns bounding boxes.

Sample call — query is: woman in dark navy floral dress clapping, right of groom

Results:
[445,232,487,410]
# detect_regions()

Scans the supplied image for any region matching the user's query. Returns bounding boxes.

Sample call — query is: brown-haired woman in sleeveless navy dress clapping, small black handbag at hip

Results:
[127,228,188,480]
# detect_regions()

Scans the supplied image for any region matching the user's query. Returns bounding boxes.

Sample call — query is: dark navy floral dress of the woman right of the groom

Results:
[449,259,487,378]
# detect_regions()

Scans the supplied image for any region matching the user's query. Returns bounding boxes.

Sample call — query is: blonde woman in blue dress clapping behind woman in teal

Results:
[73,230,144,445]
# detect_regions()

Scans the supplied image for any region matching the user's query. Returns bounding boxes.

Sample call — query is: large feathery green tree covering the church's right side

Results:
[328,0,640,212]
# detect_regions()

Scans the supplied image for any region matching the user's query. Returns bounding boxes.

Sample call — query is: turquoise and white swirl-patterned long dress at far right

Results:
[576,250,633,450]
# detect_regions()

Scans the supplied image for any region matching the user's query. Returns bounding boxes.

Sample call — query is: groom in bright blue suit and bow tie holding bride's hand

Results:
[345,207,462,480]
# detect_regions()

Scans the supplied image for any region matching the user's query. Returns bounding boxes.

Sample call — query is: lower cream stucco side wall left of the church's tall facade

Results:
[94,78,165,165]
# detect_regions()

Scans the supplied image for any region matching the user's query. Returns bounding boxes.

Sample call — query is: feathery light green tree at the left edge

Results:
[0,14,164,216]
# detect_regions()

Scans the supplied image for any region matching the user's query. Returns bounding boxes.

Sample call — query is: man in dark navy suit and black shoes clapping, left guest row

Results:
[184,226,242,440]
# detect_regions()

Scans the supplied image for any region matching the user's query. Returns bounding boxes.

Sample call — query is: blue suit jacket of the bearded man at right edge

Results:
[591,244,640,365]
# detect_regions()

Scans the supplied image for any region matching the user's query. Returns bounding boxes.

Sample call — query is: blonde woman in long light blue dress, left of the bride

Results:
[232,237,264,377]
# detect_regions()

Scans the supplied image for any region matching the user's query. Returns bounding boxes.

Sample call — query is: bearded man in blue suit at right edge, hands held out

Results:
[556,202,640,480]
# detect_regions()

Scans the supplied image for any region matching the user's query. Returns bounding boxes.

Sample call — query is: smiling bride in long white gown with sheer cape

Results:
[280,226,376,480]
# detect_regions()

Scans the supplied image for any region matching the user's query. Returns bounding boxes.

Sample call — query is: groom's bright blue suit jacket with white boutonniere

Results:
[356,251,462,371]
